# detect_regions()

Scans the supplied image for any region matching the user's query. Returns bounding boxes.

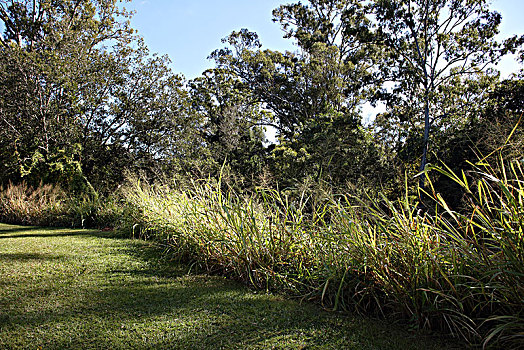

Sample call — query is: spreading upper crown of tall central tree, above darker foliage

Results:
[211,0,374,136]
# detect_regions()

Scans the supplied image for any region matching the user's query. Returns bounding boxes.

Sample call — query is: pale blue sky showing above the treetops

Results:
[125,0,524,79]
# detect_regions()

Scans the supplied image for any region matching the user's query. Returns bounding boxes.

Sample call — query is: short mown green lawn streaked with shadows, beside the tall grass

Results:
[0,224,459,350]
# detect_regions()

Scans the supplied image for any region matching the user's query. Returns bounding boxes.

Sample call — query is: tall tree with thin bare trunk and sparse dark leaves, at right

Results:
[373,0,523,186]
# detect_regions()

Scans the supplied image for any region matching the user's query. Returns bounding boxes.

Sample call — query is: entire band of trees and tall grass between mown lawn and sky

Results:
[0,0,524,348]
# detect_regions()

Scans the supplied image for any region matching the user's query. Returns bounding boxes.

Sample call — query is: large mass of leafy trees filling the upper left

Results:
[0,0,191,194]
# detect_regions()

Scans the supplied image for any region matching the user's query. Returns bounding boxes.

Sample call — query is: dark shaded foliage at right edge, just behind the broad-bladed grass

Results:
[424,79,524,210]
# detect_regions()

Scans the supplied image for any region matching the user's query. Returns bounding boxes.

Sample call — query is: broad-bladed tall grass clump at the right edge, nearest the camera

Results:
[428,157,524,347]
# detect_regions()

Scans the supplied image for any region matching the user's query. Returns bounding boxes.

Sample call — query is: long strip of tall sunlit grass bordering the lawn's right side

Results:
[115,160,524,347]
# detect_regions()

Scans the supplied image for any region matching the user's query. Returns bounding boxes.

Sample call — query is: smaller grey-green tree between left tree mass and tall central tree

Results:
[187,68,267,186]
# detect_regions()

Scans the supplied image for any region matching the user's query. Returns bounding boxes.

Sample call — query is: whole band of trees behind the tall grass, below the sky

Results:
[0,0,524,202]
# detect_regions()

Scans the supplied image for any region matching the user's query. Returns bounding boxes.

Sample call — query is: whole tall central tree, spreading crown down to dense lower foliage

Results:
[212,0,386,191]
